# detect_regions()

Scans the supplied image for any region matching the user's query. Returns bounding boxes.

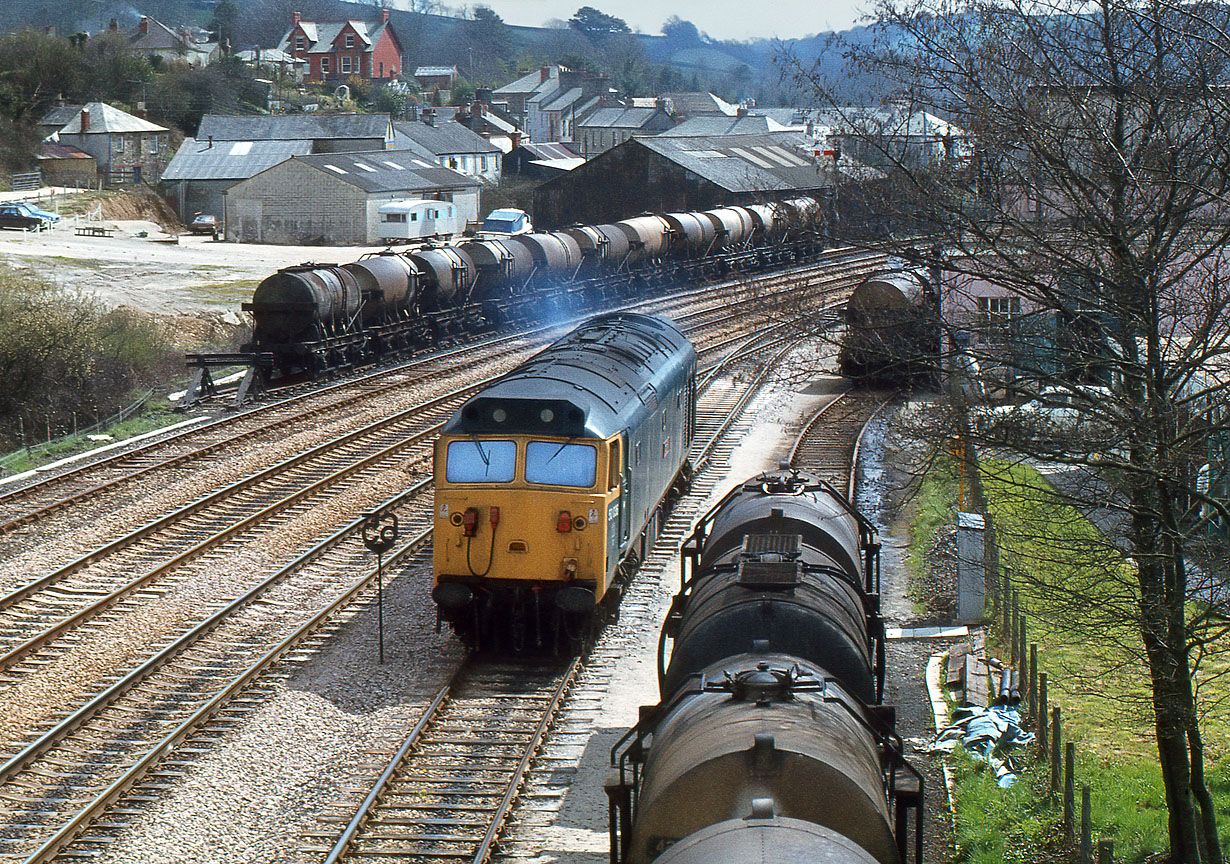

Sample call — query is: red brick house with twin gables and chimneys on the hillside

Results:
[278,9,401,81]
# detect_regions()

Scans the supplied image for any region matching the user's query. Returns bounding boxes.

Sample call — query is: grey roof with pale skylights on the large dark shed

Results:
[634,132,827,192]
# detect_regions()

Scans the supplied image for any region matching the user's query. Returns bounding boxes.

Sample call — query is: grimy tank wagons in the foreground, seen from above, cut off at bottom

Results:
[606,470,923,864]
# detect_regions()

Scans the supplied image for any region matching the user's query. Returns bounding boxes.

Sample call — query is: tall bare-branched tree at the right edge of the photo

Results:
[791,0,1230,863]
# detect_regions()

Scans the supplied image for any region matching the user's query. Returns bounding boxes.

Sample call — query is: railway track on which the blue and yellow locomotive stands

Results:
[304,315,806,864]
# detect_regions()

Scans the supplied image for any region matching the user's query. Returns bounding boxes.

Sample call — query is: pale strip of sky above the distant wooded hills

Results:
[445,0,871,41]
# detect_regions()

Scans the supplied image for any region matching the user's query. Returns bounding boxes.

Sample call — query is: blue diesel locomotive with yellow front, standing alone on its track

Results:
[432,314,696,652]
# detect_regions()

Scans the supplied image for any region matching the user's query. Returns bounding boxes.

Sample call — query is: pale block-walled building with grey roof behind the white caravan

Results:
[225,150,482,245]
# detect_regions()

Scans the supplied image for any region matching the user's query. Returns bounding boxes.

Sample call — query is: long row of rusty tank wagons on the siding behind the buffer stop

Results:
[236,198,822,383]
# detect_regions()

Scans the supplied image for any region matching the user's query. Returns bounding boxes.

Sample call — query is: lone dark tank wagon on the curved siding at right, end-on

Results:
[839,270,940,382]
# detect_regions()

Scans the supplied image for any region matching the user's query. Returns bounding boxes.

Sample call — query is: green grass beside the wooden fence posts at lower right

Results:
[910,463,1230,864]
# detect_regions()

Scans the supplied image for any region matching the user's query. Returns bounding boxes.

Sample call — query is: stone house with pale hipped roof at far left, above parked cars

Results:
[43,102,171,185]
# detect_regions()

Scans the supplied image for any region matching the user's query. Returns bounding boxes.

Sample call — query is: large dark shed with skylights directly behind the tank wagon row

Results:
[534,132,831,230]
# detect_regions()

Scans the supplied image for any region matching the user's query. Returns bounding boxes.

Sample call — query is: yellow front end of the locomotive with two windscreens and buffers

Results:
[433,434,621,649]
